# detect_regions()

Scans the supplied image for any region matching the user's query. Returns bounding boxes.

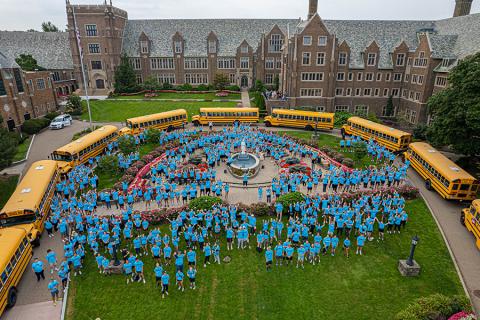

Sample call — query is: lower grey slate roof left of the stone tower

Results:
[0,31,73,70]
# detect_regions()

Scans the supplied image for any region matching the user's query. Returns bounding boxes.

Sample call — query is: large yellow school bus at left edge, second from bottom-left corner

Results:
[0,160,60,245]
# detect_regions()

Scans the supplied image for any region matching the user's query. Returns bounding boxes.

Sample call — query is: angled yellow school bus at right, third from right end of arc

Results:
[342,117,412,152]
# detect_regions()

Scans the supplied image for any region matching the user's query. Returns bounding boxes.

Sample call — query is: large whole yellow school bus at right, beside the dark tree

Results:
[404,142,479,200]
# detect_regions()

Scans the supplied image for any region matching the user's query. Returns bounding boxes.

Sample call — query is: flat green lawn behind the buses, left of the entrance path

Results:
[82,100,242,122]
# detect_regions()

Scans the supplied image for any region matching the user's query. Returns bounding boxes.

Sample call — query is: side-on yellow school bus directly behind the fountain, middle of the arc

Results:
[192,108,259,126]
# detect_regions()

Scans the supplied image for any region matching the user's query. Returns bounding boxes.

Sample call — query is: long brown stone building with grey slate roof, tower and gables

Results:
[66,0,480,124]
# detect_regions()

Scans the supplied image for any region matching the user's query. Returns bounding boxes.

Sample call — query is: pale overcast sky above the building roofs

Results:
[0,0,480,30]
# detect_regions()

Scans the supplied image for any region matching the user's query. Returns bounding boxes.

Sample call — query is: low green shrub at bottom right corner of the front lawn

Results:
[395,293,471,320]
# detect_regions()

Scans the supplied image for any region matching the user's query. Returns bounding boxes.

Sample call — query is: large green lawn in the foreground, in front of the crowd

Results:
[67,199,463,320]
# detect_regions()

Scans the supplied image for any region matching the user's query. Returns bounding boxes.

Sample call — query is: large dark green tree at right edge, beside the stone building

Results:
[427,53,480,156]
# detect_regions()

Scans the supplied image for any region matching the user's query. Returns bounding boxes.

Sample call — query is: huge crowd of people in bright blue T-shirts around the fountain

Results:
[32,126,408,303]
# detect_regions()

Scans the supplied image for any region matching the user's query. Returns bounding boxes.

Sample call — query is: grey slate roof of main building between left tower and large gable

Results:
[122,19,299,57]
